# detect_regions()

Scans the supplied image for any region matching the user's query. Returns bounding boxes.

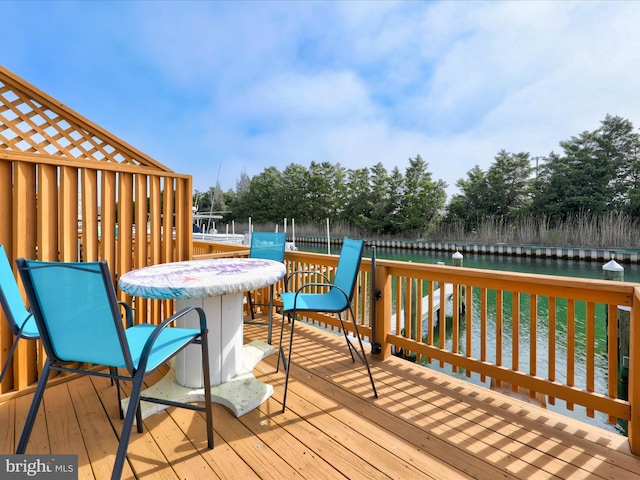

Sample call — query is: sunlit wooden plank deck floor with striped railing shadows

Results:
[0,316,640,480]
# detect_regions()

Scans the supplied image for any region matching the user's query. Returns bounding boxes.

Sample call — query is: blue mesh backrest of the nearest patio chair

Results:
[16,258,133,372]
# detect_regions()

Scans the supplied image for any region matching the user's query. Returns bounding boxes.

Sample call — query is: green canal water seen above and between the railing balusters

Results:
[297,244,640,434]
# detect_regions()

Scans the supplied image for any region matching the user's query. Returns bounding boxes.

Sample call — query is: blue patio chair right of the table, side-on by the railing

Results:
[276,237,378,413]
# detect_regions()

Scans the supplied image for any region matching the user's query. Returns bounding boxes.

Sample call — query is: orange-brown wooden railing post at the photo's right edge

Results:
[628,287,640,455]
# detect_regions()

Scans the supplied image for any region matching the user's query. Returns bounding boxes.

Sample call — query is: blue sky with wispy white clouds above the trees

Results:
[0,0,640,199]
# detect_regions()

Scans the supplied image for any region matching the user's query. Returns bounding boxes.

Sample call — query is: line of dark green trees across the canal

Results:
[195,115,640,244]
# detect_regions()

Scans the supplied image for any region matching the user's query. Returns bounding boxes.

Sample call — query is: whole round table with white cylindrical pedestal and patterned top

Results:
[119,258,285,418]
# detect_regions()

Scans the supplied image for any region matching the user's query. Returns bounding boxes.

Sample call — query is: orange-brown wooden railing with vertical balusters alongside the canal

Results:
[194,247,640,454]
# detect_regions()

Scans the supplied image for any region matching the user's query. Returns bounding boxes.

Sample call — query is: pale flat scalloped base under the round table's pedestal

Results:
[122,340,275,418]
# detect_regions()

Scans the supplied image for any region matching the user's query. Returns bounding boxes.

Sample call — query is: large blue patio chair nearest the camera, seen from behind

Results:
[16,258,213,479]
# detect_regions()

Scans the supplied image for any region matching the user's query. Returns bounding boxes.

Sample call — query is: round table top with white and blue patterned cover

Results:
[119,258,285,300]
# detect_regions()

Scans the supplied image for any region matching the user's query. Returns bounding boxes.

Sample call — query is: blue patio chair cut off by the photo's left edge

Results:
[0,245,40,383]
